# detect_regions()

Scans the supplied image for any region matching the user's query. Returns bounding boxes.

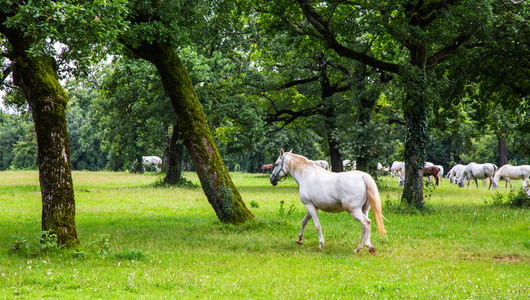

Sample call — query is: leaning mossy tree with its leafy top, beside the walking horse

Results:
[120,1,253,224]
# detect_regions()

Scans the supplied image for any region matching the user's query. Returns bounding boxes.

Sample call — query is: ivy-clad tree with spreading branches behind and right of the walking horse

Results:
[260,0,500,207]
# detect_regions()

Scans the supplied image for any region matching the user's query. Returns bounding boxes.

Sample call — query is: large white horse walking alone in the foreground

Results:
[270,149,386,254]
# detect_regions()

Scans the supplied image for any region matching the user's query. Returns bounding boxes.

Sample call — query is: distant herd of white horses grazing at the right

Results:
[389,161,530,190]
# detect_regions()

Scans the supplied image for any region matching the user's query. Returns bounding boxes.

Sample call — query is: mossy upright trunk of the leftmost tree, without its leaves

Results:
[0,27,79,247]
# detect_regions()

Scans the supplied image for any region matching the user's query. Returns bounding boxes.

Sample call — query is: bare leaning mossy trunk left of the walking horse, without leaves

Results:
[130,42,254,224]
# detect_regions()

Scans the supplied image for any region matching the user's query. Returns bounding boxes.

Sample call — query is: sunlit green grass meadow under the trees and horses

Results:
[0,171,530,299]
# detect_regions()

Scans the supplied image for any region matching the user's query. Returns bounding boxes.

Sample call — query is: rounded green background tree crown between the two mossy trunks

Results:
[91,59,171,169]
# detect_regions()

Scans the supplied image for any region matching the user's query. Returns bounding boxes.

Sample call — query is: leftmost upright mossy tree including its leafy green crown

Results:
[0,1,126,247]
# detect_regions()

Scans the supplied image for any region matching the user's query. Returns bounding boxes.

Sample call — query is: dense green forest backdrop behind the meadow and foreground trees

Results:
[0,1,530,176]
